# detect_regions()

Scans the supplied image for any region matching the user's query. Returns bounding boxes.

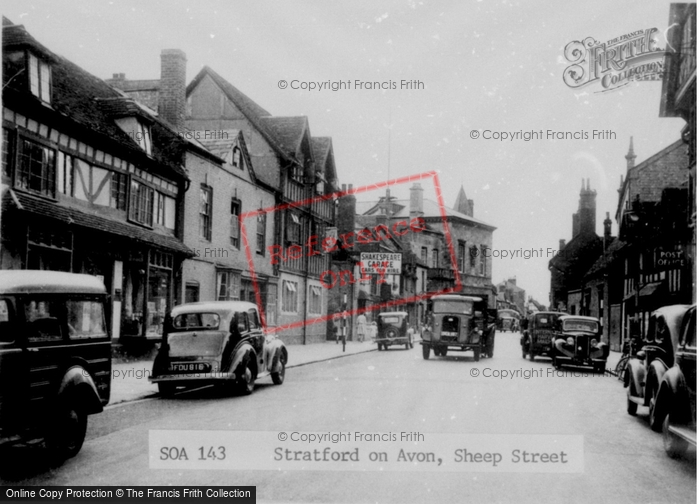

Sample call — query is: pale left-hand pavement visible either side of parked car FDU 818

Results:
[108,341,377,407]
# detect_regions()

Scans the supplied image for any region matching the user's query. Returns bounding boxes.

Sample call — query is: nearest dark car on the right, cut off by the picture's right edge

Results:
[656,306,698,457]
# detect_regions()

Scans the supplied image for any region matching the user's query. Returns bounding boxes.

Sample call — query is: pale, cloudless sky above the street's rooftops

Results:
[0,0,684,304]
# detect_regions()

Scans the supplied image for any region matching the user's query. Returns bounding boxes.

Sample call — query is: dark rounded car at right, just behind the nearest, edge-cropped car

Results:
[624,305,690,432]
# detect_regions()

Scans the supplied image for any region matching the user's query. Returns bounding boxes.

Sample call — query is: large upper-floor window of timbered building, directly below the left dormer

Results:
[15,139,56,198]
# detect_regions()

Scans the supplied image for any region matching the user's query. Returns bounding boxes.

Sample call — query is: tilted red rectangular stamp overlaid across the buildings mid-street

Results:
[239,171,466,333]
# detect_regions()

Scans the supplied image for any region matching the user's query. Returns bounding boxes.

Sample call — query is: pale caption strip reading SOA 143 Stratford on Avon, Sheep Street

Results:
[149,430,584,473]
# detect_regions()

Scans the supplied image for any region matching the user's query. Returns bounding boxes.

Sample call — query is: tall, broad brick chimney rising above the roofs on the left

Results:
[158,49,187,131]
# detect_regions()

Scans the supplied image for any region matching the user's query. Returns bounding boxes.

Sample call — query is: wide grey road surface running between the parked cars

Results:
[0,333,696,503]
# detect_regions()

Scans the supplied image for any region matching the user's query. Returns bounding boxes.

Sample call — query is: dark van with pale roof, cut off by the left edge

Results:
[0,270,112,460]
